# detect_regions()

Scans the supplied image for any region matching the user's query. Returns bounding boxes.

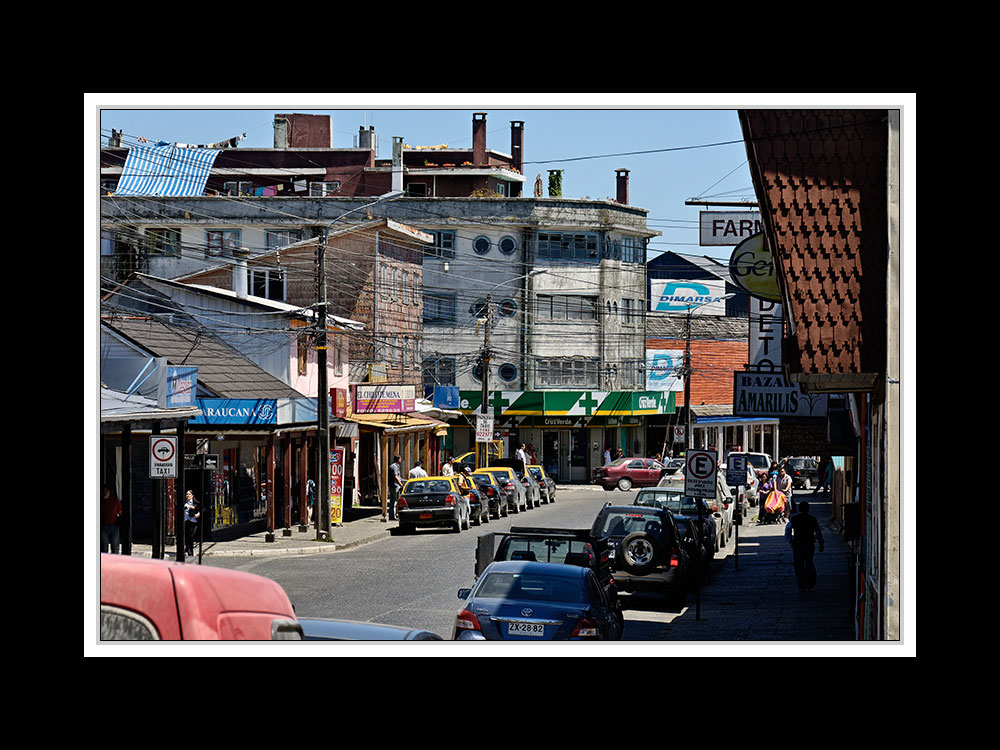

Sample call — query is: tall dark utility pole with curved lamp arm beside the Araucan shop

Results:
[316,190,405,541]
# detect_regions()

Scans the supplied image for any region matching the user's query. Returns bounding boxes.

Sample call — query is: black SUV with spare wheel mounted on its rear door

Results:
[590,503,691,604]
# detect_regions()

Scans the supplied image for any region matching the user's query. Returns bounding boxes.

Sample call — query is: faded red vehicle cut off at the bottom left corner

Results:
[101,554,303,641]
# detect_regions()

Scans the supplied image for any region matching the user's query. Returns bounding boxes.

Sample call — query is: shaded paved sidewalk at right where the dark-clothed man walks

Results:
[660,493,855,643]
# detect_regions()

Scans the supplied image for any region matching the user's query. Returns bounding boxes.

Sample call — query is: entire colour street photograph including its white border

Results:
[85,95,913,656]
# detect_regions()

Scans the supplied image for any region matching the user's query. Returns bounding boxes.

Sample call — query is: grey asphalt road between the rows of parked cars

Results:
[204,487,731,641]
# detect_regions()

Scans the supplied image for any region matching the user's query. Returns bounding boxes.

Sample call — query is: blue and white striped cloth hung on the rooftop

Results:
[114,144,219,197]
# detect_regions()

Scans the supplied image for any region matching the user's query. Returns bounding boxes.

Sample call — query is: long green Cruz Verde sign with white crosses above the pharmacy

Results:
[459,391,676,418]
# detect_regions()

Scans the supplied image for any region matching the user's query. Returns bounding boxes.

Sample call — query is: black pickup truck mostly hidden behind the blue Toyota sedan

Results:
[476,526,625,628]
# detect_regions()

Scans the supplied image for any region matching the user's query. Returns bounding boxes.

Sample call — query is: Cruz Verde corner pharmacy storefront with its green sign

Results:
[452,391,674,483]
